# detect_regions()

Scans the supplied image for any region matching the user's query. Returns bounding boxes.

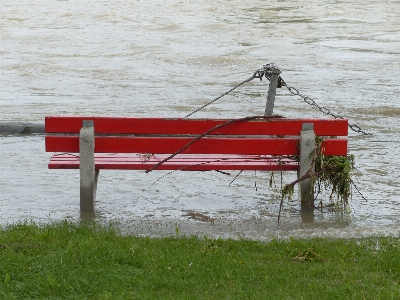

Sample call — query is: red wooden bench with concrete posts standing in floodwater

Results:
[45,116,348,211]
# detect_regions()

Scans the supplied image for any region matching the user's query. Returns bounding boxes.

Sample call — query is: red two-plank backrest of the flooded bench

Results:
[45,116,348,155]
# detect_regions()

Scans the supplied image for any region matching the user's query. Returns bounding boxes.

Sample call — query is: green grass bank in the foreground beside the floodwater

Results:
[0,222,400,299]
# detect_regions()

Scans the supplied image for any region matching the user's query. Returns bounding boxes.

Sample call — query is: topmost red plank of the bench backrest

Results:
[45,116,348,136]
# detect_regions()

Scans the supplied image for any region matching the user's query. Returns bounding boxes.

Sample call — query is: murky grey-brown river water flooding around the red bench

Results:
[0,0,400,239]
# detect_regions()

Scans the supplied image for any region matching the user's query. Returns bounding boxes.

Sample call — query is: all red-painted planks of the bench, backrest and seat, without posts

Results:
[46,117,348,171]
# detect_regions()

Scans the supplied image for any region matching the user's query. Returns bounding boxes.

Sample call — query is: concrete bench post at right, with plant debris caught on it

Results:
[297,123,316,211]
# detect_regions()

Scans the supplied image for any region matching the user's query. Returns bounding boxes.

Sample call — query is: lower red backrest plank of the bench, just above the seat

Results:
[46,136,347,155]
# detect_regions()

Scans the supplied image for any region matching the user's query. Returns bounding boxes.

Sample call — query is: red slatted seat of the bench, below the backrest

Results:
[49,154,298,171]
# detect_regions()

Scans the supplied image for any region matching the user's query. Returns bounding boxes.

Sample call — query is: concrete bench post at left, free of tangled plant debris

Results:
[79,120,99,212]
